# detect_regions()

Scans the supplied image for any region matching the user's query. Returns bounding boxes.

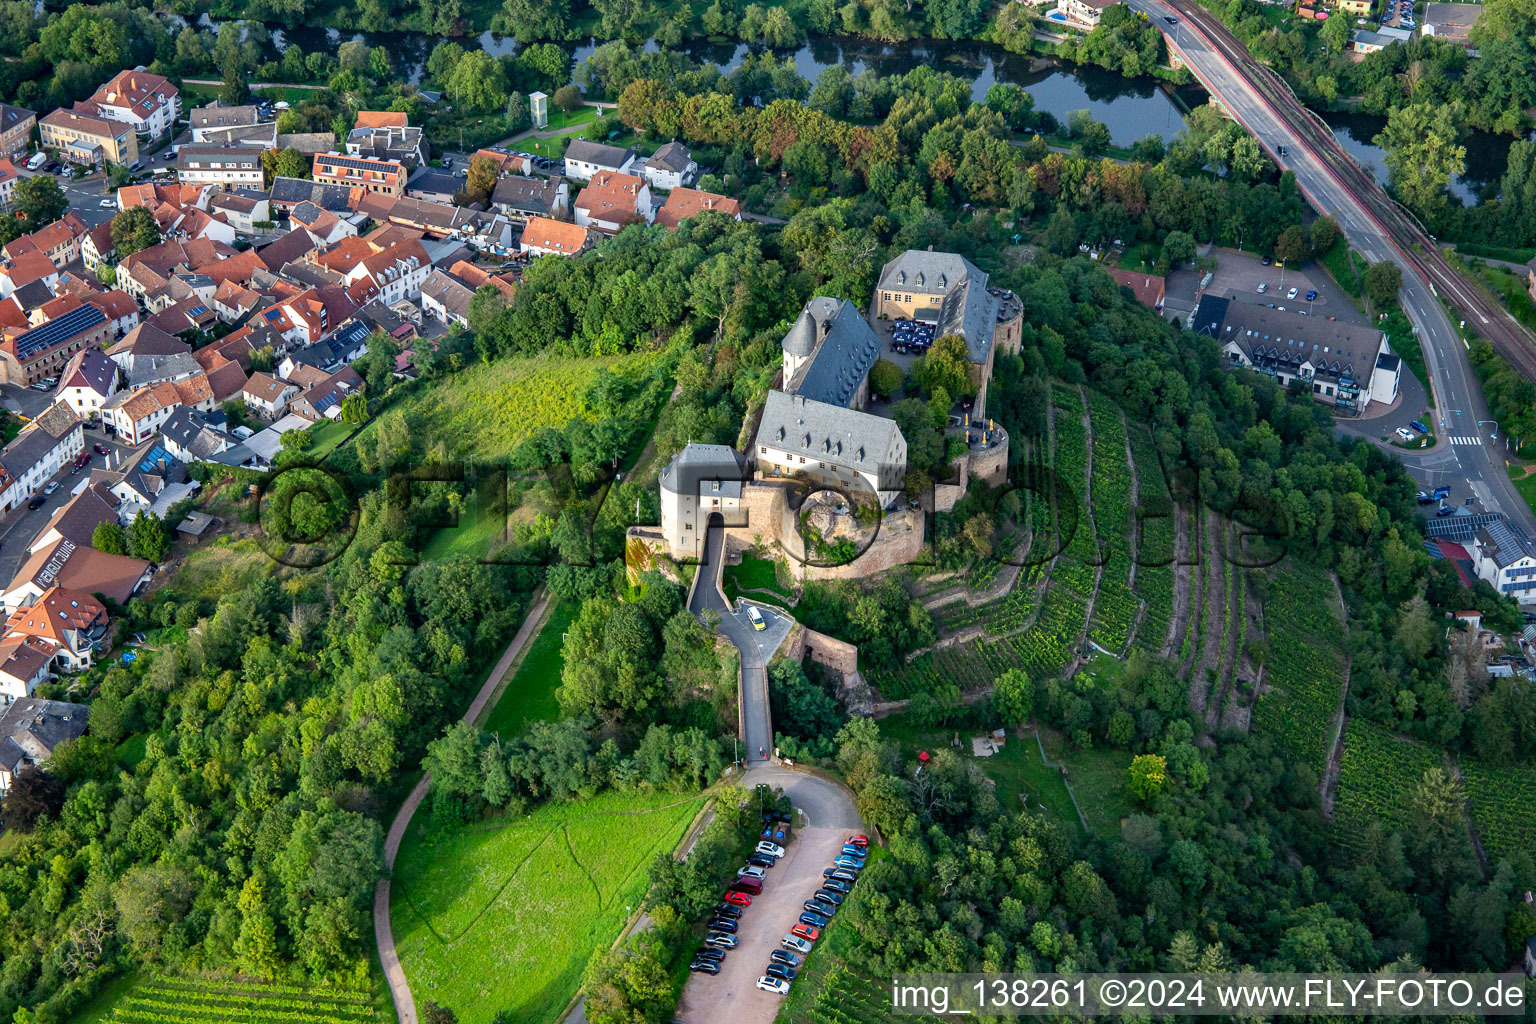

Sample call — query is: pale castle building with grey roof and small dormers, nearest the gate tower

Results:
[754,391,906,508]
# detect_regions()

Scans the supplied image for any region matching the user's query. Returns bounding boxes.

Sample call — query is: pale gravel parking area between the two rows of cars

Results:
[673,826,851,1024]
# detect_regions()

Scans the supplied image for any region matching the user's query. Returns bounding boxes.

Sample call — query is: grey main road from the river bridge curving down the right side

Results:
[1155,0,1536,536]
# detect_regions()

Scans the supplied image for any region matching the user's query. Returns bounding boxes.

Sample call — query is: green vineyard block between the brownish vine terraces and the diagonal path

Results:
[1247,563,1344,772]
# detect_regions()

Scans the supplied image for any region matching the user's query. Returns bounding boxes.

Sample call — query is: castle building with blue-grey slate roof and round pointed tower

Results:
[782,296,880,408]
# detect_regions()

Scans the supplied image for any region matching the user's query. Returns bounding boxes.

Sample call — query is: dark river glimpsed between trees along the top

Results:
[230,15,1513,180]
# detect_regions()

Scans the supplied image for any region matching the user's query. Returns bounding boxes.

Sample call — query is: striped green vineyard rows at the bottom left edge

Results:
[92,976,379,1024]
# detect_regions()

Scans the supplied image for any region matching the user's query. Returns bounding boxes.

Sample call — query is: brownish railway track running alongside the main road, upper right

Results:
[1177,3,1536,381]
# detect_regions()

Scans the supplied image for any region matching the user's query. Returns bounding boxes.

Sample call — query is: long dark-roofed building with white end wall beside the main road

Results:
[1190,295,1402,413]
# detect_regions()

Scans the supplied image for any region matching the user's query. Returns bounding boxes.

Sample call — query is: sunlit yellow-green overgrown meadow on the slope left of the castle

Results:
[369,353,665,459]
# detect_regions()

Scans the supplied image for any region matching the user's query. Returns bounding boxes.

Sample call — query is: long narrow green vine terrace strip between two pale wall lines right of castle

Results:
[1087,391,1141,654]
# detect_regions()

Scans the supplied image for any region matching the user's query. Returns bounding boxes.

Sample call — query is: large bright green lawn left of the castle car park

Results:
[392,792,703,1024]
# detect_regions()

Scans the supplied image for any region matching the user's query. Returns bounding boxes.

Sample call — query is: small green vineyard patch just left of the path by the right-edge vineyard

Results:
[1333,718,1445,844]
